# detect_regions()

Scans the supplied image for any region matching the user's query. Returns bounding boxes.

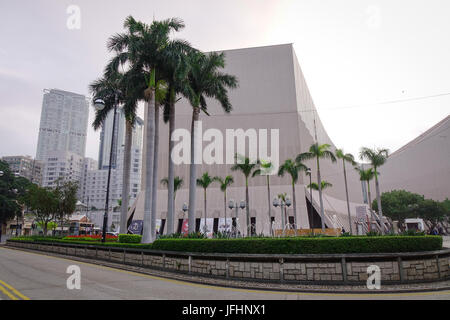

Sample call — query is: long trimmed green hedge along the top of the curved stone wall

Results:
[10,236,442,254]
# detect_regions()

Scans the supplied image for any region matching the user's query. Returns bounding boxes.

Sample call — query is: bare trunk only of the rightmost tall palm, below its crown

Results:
[188,107,200,233]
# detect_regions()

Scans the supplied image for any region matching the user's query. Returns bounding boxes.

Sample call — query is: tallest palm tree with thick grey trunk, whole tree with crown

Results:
[109,16,188,243]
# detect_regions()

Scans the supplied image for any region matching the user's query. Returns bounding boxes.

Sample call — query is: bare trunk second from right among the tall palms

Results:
[167,89,175,234]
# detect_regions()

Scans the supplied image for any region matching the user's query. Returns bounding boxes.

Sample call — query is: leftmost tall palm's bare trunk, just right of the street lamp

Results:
[120,120,133,233]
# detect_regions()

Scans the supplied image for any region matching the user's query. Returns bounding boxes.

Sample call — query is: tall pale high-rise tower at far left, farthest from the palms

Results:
[36,89,89,162]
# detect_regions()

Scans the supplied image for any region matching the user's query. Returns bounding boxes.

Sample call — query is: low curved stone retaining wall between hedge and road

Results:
[7,240,450,284]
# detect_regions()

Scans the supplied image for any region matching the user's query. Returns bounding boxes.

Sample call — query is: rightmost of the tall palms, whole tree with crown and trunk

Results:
[184,51,237,232]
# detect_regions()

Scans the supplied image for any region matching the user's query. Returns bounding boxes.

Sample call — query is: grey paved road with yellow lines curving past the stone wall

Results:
[0,247,450,300]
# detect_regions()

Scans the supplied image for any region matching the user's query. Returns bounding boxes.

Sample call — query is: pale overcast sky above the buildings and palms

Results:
[0,0,450,159]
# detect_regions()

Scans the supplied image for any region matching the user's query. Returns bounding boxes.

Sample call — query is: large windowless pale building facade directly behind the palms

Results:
[129,44,370,234]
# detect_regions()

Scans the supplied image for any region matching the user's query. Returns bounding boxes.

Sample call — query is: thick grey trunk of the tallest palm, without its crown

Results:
[142,96,155,243]
